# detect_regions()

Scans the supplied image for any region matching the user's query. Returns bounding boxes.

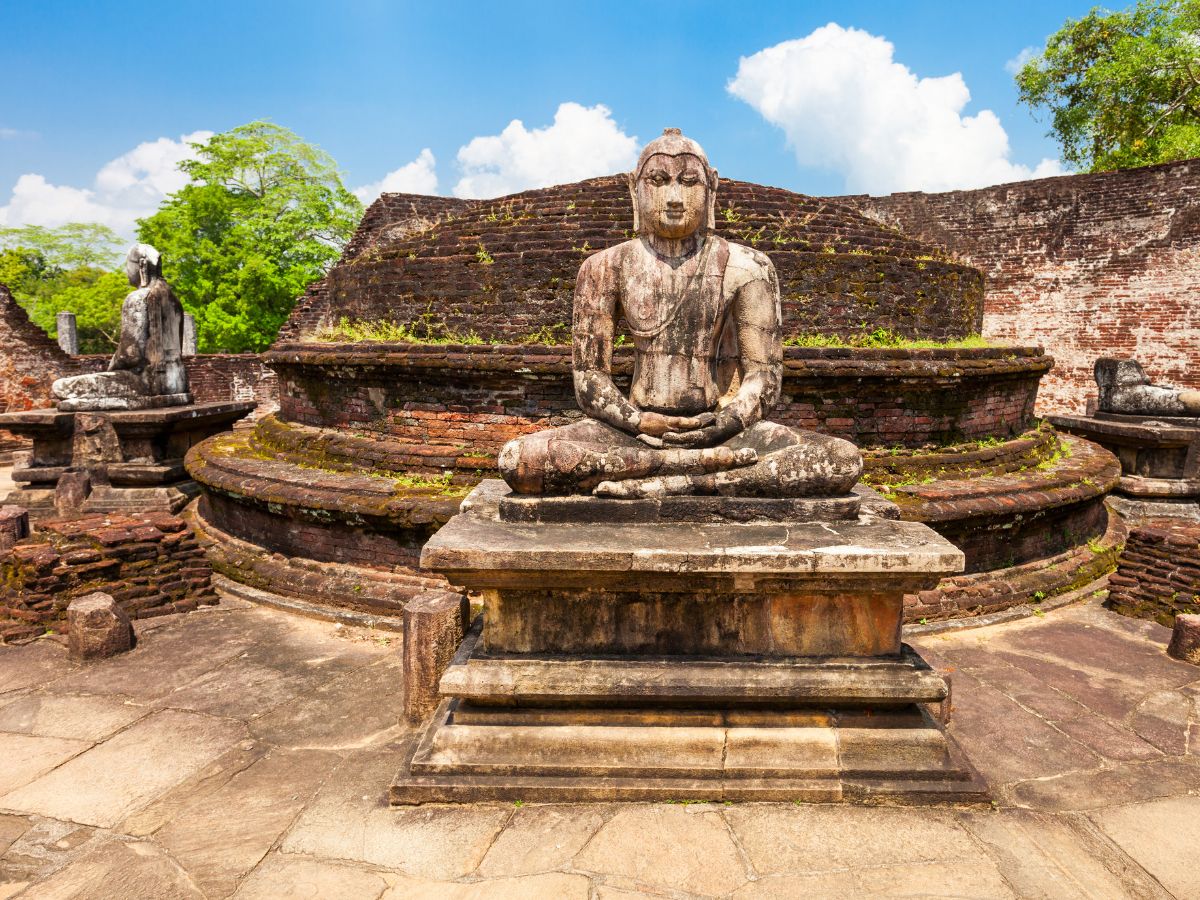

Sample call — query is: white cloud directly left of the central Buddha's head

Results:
[454,103,637,198]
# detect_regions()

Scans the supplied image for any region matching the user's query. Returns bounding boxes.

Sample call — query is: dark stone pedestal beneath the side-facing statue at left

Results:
[0,402,254,517]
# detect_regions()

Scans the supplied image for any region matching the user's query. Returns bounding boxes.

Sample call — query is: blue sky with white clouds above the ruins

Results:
[0,0,1091,236]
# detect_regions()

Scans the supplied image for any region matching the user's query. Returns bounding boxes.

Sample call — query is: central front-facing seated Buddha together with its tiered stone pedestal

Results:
[390,128,985,804]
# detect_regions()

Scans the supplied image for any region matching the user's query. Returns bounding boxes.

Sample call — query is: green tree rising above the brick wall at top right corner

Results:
[1016,0,1200,172]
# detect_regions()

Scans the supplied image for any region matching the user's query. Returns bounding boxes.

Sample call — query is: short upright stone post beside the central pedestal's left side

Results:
[402,590,470,725]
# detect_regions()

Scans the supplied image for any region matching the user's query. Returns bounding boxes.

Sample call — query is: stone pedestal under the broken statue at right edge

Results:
[1049,412,1200,520]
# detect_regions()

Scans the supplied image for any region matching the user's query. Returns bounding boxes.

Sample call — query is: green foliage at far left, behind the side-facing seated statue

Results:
[0,222,132,353]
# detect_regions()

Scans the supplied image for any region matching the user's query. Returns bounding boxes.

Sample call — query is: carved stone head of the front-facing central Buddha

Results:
[629,128,716,240]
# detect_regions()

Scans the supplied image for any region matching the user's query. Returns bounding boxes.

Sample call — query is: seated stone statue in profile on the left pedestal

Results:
[52,244,192,409]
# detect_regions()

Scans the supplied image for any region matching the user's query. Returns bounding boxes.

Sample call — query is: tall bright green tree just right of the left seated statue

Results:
[138,121,362,353]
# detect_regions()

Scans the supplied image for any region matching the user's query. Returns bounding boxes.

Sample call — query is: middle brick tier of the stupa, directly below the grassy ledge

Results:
[266,343,1052,451]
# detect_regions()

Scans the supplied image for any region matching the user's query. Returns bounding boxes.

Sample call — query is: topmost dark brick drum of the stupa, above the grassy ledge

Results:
[280,176,983,342]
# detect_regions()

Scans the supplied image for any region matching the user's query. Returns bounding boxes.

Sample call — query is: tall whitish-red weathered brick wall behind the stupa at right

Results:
[836,160,1200,412]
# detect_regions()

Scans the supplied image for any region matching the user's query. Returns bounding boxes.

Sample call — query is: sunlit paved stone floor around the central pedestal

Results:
[0,600,1200,900]
